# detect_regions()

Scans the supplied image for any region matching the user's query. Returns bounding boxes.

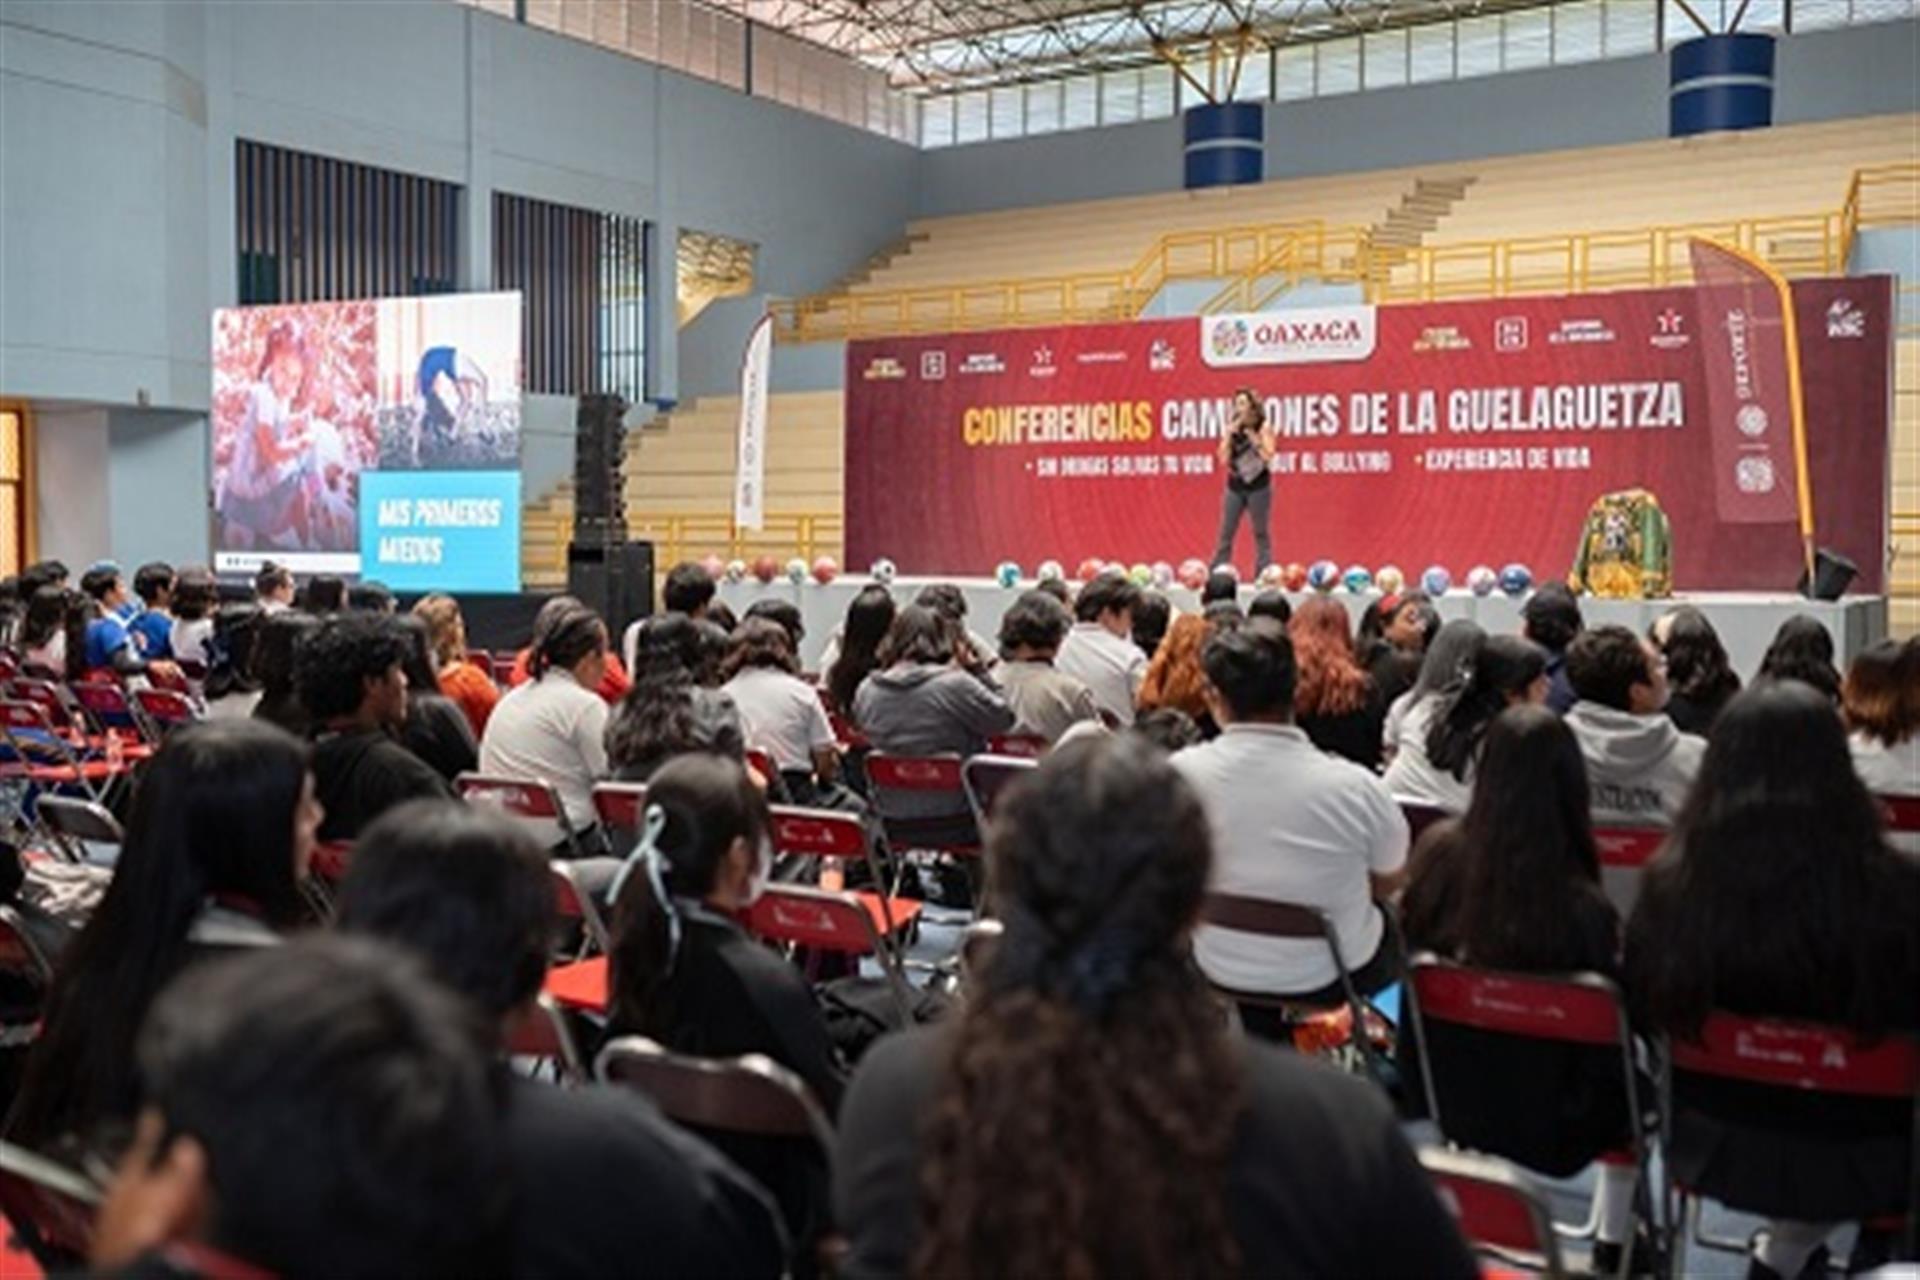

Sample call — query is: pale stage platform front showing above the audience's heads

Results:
[720,576,1887,679]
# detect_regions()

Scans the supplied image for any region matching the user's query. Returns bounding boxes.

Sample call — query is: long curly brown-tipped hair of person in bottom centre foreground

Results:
[912,733,1242,1276]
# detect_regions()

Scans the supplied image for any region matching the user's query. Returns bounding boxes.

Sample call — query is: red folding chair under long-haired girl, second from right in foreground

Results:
[1405,952,1657,1276]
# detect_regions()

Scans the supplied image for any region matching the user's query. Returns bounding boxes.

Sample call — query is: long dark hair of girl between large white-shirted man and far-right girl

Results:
[1442,706,1611,971]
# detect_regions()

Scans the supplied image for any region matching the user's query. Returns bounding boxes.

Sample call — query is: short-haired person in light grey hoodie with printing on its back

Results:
[1567,626,1707,825]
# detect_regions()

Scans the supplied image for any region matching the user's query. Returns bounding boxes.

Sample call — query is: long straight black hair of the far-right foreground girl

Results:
[1626,681,1920,1034]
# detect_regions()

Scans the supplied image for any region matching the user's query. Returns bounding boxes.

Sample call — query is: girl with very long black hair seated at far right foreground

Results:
[1626,681,1920,1278]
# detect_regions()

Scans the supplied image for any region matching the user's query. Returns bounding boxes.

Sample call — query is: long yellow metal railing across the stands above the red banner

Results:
[772,163,1920,342]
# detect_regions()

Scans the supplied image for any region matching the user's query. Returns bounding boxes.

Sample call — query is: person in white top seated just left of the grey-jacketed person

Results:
[720,610,839,804]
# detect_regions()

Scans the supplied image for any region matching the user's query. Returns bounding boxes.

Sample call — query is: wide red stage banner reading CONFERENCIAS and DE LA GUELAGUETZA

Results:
[847,276,1893,593]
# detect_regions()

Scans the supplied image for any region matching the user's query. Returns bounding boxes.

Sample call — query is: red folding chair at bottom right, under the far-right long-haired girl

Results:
[1661,1011,1920,1257]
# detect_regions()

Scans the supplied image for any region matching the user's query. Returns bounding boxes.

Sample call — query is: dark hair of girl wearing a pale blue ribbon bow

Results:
[607,754,772,1036]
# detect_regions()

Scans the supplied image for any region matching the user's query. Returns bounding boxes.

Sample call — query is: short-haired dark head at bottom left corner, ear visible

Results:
[92,936,509,1280]
